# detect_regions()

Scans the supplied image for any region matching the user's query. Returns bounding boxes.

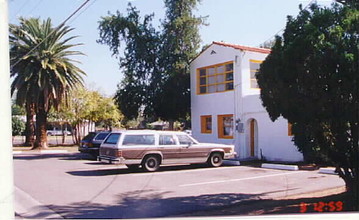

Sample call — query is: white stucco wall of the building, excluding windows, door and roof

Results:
[191,44,303,161]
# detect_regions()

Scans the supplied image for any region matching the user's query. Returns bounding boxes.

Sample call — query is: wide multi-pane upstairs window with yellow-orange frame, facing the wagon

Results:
[197,61,233,94]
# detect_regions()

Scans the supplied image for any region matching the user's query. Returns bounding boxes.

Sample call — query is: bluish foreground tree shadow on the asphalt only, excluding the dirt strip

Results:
[45,190,259,219]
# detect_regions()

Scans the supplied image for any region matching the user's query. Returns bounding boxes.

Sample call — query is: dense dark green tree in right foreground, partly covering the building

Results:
[257,1,359,209]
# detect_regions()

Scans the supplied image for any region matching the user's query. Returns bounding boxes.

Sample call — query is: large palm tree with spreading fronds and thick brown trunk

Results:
[10,18,85,149]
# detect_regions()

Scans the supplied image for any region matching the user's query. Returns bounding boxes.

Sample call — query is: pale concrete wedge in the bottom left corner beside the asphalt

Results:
[14,186,63,219]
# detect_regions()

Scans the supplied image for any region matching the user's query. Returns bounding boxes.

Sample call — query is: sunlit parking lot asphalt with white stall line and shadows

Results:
[14,154,344,218]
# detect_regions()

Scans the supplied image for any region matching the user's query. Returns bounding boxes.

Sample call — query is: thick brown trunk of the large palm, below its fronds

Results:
[32,106,48,150]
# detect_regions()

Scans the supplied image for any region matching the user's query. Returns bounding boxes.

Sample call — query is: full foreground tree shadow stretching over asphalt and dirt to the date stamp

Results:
[23,190,358,219]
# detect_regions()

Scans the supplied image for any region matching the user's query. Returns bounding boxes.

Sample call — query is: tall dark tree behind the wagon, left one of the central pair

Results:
[98,4,160,119]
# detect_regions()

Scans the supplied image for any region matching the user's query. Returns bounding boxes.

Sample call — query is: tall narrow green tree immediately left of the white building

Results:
[153,0,203,128]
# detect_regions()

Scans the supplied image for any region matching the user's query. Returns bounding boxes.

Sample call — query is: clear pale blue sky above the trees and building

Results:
[8,0,331,96]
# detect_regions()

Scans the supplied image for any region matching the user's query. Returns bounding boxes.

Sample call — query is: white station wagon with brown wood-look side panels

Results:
[98,130,236,171]
